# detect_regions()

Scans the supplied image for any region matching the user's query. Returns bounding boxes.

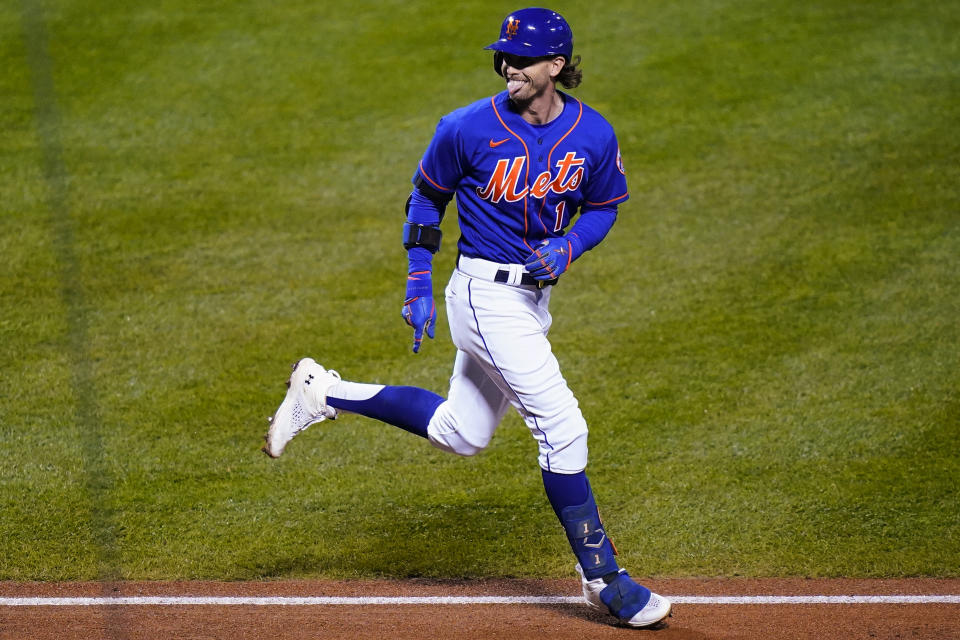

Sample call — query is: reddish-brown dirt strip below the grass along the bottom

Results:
[0,579,960,640]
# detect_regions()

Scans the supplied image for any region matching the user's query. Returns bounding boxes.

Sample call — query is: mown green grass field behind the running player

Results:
[0,0,960,581]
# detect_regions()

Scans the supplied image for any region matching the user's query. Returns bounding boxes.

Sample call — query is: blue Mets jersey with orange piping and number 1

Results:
[413,91,629,264]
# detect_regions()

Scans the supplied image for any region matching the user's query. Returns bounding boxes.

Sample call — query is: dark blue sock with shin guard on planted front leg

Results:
[541,469,620,580]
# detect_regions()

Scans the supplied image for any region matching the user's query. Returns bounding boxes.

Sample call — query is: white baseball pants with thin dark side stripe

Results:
[427,257,587,473]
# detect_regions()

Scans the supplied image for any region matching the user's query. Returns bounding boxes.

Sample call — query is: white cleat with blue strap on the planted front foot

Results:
[576,564,671,627]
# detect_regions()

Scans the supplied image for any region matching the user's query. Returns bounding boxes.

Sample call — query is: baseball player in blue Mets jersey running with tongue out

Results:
[264,8,671,627]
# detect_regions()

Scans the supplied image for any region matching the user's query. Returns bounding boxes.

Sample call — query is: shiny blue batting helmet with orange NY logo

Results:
[484,7,573,61]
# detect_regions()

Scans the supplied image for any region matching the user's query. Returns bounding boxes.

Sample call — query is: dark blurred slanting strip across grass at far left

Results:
[21,0,119,589]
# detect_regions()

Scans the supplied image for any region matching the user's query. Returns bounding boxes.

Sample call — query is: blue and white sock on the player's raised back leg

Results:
[327,382,443,438]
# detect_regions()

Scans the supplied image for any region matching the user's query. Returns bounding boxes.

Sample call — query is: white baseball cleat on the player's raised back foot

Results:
[261,358,340,458]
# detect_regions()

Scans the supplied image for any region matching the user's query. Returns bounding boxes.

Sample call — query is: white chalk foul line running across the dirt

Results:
[0,595,960,607]
